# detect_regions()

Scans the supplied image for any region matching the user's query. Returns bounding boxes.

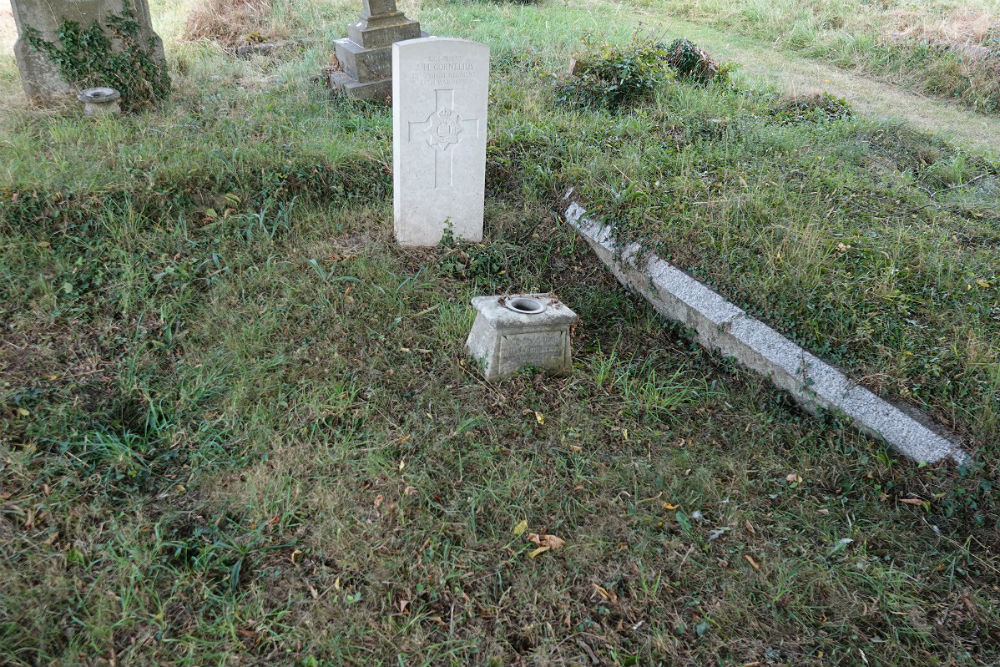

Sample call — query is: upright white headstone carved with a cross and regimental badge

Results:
[392,37,490,246]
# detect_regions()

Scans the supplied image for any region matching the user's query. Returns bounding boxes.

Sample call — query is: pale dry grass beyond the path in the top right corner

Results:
[642,0,1000,114]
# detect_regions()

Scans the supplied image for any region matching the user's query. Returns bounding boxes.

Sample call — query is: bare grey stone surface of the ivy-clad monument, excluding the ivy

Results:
[12,0,166,102]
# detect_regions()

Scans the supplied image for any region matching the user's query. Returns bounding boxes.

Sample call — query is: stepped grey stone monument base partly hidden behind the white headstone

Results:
[330,0,427,99]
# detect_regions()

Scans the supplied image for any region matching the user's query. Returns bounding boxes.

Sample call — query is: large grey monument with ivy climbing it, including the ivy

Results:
[12,0,169,102]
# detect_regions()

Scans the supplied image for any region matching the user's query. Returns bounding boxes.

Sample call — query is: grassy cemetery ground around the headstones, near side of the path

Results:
[0,0,1000,665]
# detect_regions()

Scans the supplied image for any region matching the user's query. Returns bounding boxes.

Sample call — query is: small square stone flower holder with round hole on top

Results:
[465,294,579,382]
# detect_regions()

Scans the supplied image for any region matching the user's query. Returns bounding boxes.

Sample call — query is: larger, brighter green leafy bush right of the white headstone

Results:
[557,38,672,110]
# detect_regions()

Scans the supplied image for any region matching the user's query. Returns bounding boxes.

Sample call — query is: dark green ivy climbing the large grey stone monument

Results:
[25,6,170,111]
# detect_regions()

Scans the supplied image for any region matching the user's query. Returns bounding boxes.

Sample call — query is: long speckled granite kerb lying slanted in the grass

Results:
[563,189,968,464]
